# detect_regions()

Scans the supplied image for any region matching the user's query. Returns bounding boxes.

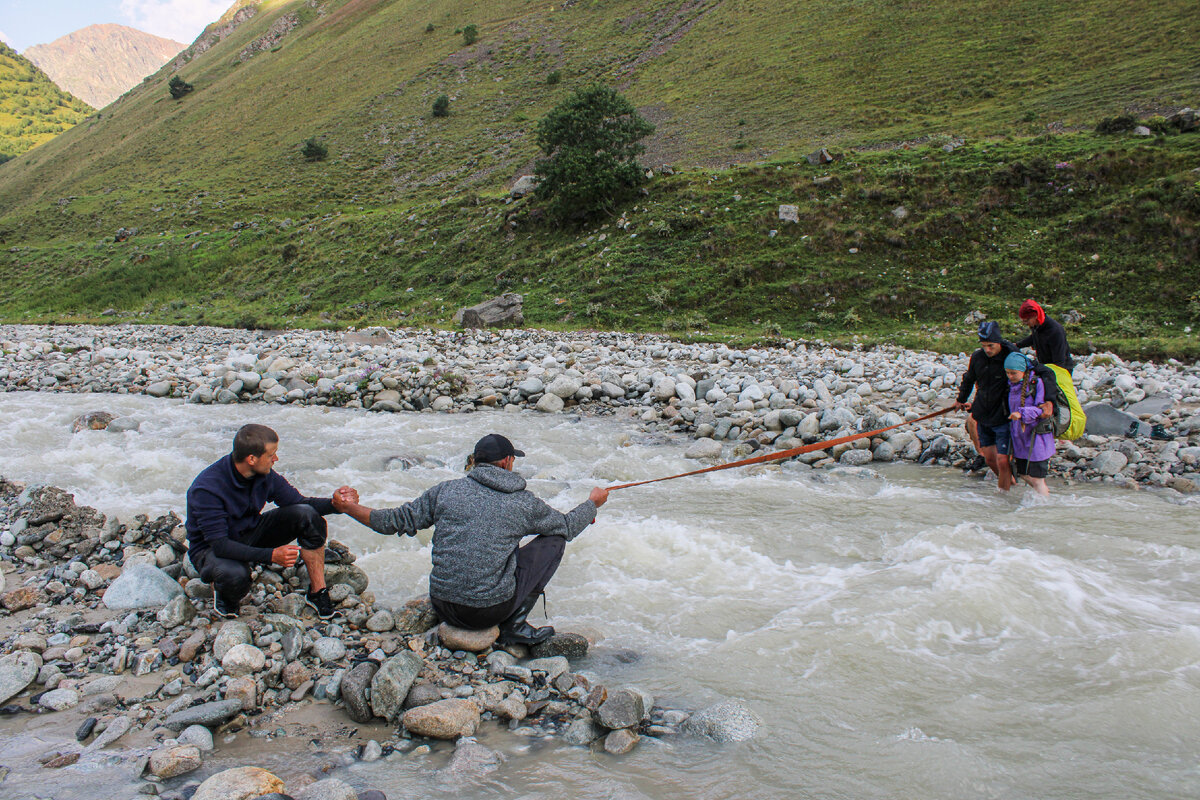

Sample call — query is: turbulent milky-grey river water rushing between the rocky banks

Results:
[0,393,1200,800]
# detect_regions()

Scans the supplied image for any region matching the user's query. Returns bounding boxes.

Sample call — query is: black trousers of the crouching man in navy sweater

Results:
[191,504,329,604]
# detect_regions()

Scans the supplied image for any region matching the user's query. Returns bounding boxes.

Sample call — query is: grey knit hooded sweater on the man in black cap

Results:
[371,464,596,608]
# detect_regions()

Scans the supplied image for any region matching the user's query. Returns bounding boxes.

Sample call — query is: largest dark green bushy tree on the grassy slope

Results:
[534,85,654,223]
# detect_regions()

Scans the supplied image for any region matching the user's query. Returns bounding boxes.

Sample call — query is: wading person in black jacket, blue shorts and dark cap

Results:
[954,321,1014,491]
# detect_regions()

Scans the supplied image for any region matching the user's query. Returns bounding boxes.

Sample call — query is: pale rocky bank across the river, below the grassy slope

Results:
[0,325,1200,493]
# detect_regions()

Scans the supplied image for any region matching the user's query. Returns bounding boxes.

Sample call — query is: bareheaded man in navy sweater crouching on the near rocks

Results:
[186,425,358,619]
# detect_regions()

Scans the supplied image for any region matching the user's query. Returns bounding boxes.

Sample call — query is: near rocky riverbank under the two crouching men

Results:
[0,479,758,800]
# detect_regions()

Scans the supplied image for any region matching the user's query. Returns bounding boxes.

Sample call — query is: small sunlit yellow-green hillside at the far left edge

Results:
[0,42,91,162]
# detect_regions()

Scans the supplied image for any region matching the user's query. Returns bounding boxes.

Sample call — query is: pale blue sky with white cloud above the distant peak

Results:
[0,0,234,53]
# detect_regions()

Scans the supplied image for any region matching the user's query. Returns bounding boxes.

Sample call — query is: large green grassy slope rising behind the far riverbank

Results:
[0,0,1200,355]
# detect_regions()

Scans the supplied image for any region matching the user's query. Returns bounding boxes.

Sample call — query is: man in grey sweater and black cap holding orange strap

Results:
[334,433,608,644]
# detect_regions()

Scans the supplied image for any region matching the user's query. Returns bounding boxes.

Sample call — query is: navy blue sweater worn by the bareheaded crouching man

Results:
[186,453,335,564]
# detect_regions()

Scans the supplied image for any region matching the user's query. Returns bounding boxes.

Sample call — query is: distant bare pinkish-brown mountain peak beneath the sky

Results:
[24,23,185,108]
